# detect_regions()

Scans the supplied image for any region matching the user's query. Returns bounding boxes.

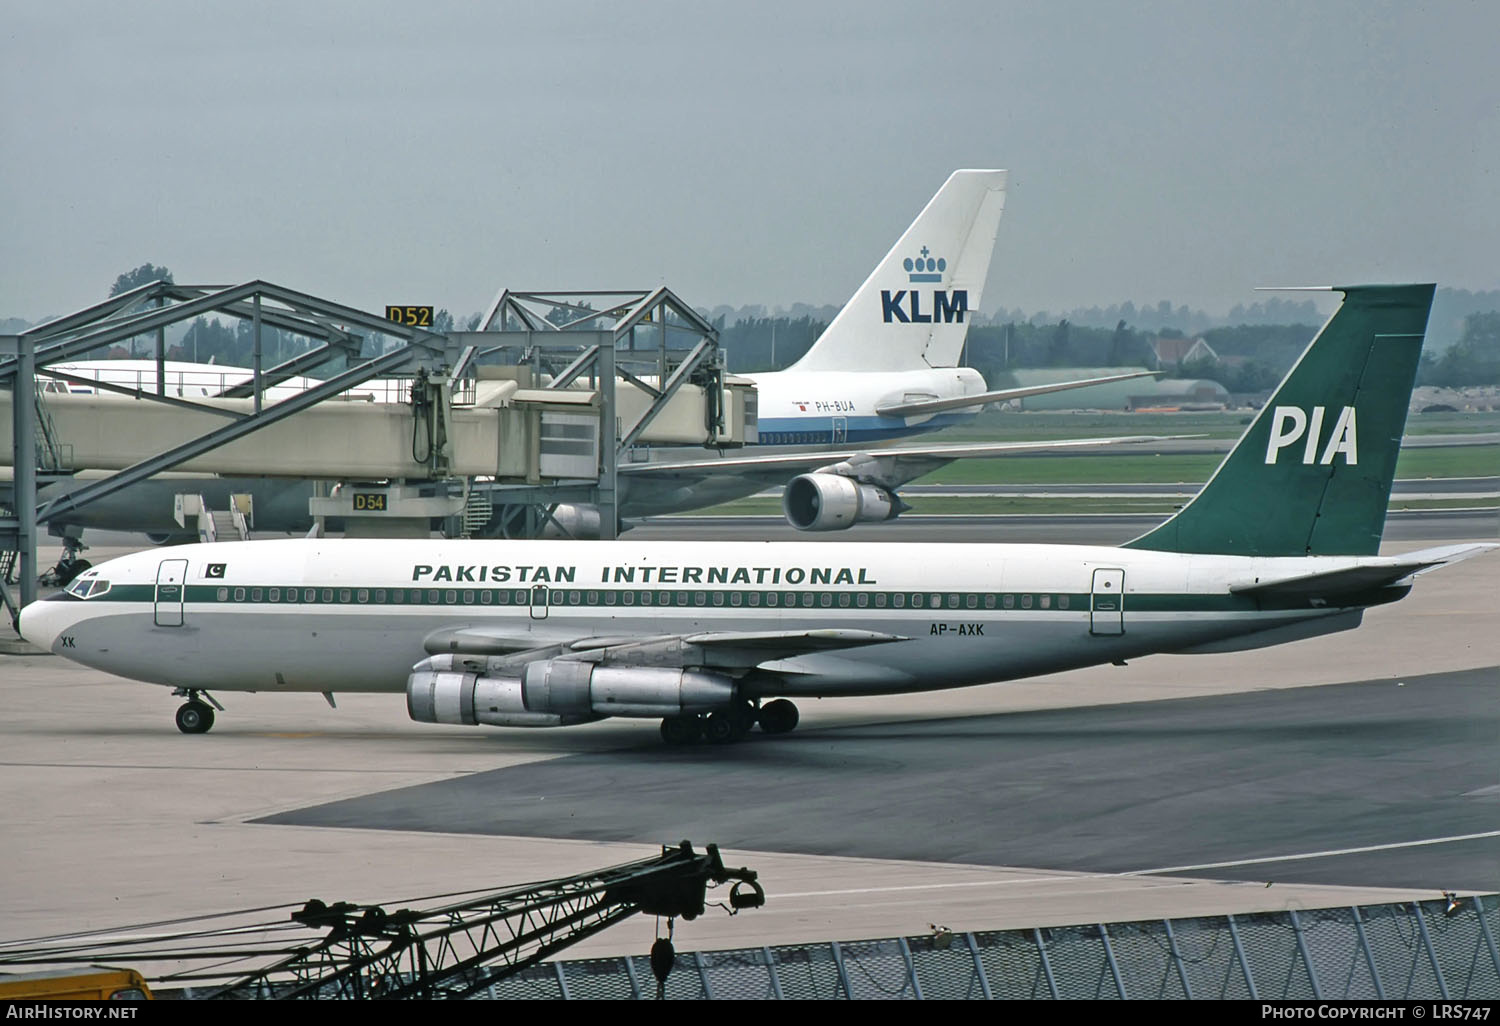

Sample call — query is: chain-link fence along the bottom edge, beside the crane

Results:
[501,894,1500,1001]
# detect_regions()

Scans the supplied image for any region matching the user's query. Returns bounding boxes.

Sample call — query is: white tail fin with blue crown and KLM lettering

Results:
[795,171,1005,371]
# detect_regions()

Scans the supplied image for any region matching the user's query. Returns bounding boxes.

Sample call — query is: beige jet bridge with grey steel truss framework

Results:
[0,281,741,614]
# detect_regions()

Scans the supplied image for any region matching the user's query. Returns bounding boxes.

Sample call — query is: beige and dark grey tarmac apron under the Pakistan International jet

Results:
[0,518,1500,954]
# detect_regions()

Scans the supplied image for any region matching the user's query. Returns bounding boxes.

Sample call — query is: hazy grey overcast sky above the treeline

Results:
[0,0,1500,320]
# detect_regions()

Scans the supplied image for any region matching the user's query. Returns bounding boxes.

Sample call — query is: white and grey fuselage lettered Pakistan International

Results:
[14,540,1406,696]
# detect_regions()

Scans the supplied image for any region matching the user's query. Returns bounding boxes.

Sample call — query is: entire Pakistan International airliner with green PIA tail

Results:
[20,285,1497,744]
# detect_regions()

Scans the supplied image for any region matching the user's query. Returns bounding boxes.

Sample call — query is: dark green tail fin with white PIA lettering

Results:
[1125,285,1434,557]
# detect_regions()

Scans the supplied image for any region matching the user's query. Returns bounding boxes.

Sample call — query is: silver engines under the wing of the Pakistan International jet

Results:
[407,656,735,726]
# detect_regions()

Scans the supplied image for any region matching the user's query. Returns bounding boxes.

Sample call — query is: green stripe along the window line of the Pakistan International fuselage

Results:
[86,585,1398,615]
